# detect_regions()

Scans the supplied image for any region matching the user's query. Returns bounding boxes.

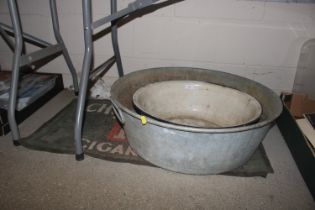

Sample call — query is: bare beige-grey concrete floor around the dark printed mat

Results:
[0,92,315,210]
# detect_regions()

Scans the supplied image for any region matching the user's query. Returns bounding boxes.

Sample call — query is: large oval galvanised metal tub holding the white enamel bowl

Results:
[111,67,282,175]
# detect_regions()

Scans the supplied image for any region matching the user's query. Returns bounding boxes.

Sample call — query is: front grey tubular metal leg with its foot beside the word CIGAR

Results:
[74,0,93,160]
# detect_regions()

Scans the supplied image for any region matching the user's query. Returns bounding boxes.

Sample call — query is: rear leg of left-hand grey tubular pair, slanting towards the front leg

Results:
[49,0,79,95]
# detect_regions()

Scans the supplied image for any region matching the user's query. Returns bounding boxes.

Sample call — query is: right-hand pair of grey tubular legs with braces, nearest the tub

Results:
[74,0,159,160]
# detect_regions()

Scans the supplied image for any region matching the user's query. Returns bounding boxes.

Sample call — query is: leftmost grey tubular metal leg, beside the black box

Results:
[8,0,23,146]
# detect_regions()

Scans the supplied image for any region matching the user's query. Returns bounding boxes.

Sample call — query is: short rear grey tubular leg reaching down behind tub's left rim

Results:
[111,0,124,77]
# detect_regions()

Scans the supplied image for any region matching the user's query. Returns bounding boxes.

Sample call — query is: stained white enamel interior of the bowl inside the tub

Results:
[133,80,262,128]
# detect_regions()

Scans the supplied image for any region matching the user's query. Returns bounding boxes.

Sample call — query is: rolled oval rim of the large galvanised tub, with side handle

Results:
[110,67,283,133]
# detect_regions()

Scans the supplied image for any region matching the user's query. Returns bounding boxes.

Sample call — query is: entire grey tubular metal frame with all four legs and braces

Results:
[0,0,163,160]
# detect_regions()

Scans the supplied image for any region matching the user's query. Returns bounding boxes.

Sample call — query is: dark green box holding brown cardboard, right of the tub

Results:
[277,93,315,201]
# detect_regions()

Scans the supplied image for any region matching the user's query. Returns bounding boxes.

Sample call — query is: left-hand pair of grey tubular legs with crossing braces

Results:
[0,0,78,146]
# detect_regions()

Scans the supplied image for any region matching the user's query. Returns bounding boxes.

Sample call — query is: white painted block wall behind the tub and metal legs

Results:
[0,0,315,92]
